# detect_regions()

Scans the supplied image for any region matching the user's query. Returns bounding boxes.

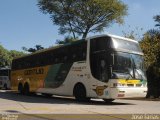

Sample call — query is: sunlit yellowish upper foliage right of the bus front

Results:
[140,29,160,68]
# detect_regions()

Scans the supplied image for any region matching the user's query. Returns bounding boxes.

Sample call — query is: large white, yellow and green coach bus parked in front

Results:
[11,34,147,102]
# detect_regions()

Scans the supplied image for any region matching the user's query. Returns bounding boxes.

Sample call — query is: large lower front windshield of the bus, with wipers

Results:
[112,52,146,80]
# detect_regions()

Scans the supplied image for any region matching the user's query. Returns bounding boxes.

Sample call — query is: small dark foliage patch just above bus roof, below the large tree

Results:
[56,36,78,44]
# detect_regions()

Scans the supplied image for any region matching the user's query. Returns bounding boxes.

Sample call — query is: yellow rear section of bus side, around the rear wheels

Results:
[11,65,50,92]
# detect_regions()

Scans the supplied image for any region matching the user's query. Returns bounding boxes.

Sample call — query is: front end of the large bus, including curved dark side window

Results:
[90,35,147,101]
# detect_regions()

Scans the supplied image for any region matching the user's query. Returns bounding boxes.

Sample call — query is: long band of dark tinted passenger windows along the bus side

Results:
[12,40,87,70]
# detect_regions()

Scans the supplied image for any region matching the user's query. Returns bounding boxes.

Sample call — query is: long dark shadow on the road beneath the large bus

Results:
[0,91,134,106]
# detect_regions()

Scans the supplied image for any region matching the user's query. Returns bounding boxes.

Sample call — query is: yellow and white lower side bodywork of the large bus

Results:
[11,61,98,97]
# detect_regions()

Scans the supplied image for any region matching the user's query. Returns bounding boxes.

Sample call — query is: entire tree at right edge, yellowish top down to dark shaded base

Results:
[140,15,160,98]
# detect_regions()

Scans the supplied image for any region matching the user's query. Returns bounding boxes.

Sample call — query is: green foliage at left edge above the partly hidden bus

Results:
[0,45,24,67]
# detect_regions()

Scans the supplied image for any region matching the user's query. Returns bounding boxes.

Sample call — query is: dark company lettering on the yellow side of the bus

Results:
[24,68,44,75]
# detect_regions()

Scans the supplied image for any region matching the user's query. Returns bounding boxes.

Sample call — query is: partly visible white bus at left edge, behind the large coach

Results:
[0,67,11,90]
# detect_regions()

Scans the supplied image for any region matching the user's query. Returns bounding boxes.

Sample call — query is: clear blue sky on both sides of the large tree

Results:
[0,0,160,51]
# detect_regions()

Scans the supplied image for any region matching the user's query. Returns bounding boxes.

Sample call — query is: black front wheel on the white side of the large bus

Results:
[73,84,90,102]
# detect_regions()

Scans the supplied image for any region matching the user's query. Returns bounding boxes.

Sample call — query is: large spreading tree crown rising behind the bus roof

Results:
[38,0,127,38]
